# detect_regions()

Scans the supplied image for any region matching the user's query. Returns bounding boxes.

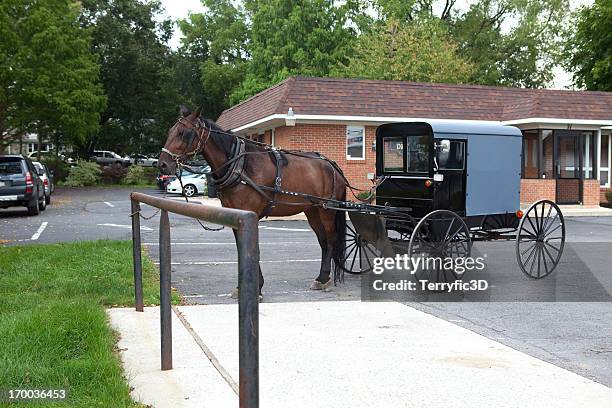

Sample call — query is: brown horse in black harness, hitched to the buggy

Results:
[158,107,348,291]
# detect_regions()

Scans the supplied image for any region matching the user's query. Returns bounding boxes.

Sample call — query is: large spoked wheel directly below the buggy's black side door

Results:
[408,210,472,291]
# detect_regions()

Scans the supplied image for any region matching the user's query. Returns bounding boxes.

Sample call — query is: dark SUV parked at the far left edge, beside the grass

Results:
[0,155,47,215]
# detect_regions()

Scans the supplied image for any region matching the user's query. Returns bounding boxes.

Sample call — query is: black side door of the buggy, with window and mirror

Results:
[434,139,467,214]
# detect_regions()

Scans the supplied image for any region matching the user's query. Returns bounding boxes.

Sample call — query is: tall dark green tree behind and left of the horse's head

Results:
[80,0,180,153]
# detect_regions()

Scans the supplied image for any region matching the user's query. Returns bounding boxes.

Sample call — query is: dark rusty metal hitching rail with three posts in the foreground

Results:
[130,192,259,408]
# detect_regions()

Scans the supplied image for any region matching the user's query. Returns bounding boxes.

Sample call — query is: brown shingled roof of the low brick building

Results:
[217,77,612,129]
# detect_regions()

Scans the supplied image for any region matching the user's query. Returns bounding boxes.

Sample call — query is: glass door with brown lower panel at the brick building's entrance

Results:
[554,130,583,204]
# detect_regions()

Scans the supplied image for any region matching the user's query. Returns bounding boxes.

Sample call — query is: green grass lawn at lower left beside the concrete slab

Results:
[0,241,178,407]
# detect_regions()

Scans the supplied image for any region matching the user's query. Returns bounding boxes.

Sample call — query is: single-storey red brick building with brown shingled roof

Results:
[217,77,612,205]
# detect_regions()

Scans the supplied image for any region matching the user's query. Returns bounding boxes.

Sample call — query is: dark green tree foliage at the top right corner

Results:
[564,0,612,91]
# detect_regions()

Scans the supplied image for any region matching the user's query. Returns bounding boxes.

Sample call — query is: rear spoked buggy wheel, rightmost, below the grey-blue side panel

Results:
[516,200,565,279]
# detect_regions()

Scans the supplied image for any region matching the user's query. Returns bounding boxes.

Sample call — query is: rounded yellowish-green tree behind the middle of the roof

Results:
[336,20,473,83]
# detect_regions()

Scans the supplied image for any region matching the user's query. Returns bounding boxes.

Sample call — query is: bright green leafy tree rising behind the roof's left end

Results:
[231,0,358,103]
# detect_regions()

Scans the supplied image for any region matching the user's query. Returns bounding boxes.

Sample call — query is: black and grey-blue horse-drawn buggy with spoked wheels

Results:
[325,121,565,283]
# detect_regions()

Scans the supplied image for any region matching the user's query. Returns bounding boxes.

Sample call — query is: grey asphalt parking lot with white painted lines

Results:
[0,188,612,386]
